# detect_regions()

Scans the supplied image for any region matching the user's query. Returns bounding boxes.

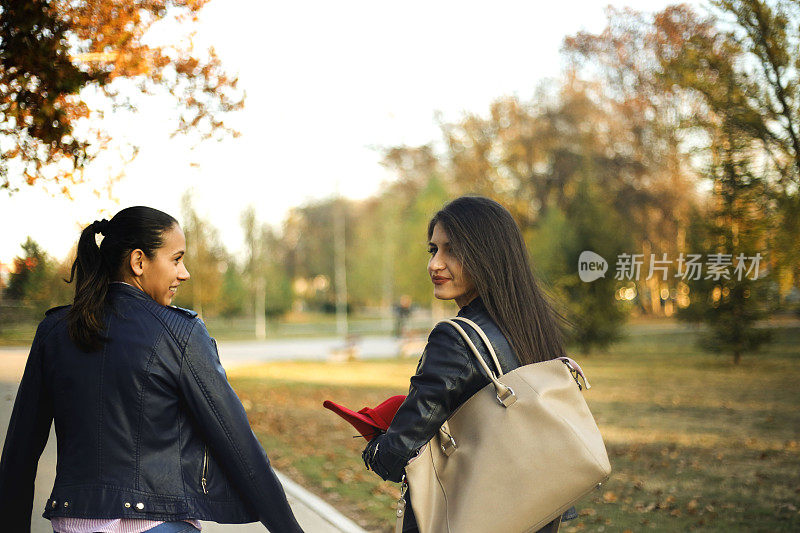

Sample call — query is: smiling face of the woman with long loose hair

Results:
[428,223,478,307]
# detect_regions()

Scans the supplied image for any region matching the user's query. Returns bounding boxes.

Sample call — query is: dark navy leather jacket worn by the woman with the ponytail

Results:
[0,283,302,533]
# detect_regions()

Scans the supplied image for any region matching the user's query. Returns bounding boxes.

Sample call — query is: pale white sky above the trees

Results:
[0,0,703,263]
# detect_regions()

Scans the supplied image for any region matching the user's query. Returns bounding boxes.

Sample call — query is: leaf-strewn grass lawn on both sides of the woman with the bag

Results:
[229,327,800,532]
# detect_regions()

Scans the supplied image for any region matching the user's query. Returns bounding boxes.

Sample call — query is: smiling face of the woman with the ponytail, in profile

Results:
[136,224,189,305]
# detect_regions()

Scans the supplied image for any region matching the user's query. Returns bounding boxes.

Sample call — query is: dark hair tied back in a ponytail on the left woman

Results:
[67,206,178,352]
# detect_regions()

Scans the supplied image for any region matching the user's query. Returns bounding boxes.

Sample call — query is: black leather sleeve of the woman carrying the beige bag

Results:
[364,324,481,481]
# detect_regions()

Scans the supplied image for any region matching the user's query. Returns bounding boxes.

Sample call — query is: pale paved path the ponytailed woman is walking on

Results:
[0,349,364,533]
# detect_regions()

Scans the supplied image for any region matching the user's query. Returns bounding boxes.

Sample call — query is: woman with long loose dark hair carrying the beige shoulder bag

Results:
[363,196,574,532]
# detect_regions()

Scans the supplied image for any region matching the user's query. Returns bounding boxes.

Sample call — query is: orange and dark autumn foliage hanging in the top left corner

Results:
[0,0,243,192]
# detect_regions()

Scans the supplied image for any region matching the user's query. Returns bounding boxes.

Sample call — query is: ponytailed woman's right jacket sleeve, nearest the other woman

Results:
[180,319,303,533]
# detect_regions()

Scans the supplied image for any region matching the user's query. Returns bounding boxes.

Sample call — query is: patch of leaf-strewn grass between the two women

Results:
[232,378,406,531]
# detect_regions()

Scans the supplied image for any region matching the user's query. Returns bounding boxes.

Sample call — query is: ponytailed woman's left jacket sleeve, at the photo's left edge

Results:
[0,325,53,531]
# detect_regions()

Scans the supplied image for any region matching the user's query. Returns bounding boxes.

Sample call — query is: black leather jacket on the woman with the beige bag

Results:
[365,297,577,523]
